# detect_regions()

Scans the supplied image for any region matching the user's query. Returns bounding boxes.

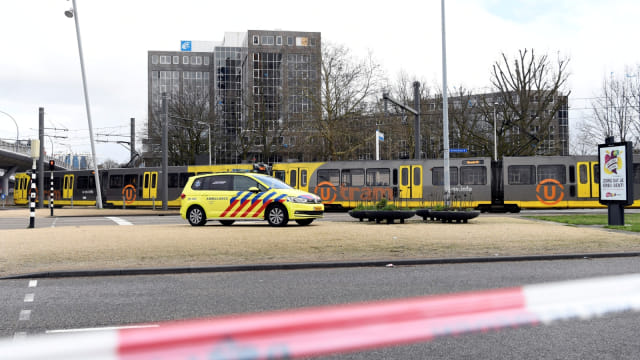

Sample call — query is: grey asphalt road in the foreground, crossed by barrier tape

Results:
[0,258,640,359]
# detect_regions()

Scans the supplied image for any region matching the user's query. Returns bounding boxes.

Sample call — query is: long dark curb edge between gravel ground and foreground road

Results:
[0,252,640,280]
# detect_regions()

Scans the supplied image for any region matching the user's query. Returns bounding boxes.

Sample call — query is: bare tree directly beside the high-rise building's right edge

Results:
[315,43,384,160]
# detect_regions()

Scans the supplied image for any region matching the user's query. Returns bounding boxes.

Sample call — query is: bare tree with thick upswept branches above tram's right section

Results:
[490,49,570,156]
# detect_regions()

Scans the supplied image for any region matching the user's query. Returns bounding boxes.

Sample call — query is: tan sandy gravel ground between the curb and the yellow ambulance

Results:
[0,209,640,276]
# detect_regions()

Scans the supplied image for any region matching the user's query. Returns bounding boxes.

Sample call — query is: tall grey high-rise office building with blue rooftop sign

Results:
[148,30,321,165]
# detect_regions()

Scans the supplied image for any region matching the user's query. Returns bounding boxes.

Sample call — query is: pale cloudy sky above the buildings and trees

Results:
[0,0,640,163]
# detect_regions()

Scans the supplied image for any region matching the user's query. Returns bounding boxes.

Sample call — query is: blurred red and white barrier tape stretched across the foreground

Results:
[5,274,640,360]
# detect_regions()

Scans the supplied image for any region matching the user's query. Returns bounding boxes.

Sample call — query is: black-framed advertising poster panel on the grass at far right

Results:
[598,142,633,205]
